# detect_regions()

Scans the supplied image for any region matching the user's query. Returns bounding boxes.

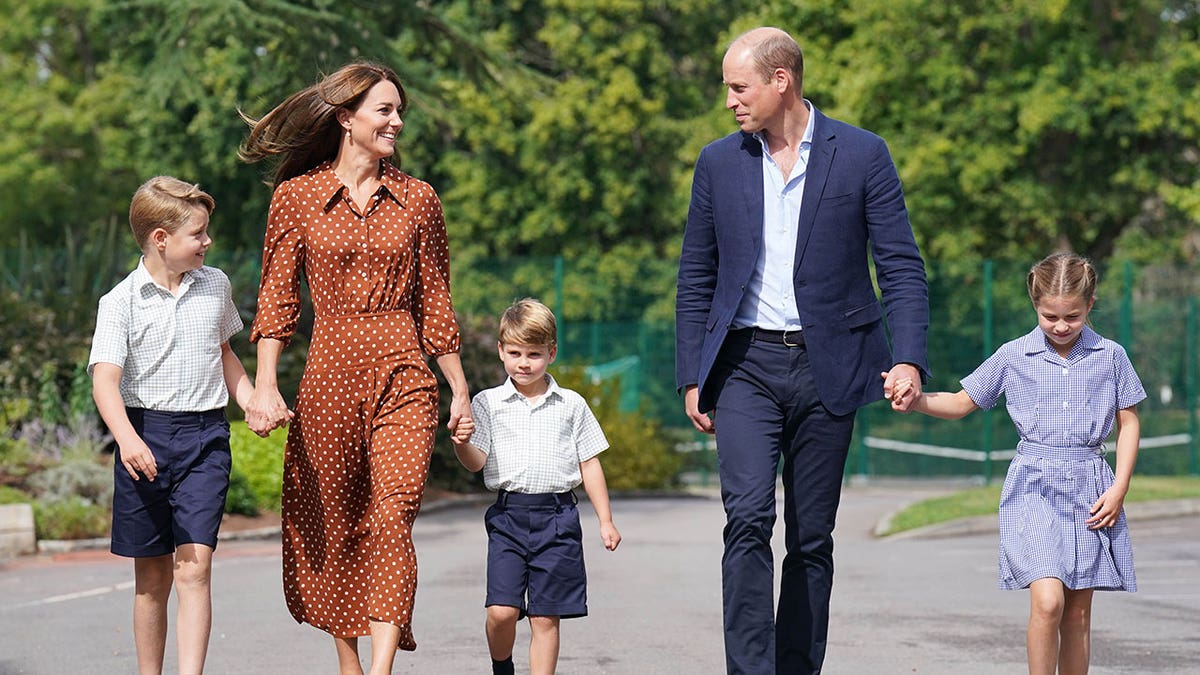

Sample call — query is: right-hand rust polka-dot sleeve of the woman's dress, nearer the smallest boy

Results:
[412,185,461,357]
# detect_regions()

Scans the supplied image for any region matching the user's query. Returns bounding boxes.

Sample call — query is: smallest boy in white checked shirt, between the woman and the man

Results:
[454,298,620,675]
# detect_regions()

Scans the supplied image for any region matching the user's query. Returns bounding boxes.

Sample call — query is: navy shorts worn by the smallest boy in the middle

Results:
[484,490,588,619]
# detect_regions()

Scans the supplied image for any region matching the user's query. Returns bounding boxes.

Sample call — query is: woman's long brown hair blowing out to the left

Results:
[238,61,408,186]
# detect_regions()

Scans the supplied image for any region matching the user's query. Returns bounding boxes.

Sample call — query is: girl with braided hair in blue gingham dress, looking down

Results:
[892,253,1146,675]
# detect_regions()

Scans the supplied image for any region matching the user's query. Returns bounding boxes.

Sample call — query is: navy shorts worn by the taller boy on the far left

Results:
[112,408,233,557]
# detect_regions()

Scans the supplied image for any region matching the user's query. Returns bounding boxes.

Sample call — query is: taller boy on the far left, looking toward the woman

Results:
[88,177,253,674]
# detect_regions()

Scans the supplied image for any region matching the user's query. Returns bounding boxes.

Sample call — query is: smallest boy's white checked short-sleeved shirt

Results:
[470,374,608,494]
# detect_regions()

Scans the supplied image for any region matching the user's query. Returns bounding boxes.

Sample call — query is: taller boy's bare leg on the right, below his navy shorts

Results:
[175,544,212,675]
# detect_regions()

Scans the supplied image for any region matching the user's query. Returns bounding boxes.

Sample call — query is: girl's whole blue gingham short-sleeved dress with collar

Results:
[962,327,1146,592]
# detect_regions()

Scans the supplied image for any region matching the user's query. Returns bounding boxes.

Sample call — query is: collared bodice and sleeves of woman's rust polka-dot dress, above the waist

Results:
[250,160,461,357]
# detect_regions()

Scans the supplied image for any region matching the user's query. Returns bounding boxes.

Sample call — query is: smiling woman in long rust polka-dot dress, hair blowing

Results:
[240,62,470,674]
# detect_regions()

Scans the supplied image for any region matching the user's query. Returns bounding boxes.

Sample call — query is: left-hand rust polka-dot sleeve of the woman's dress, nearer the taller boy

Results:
[250,181,305,344]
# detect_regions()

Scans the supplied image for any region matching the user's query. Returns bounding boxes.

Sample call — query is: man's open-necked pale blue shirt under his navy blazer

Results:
[733,100,816,330]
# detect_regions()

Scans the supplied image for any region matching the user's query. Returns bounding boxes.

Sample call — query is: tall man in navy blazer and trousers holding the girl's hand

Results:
[676,28,929,675]
